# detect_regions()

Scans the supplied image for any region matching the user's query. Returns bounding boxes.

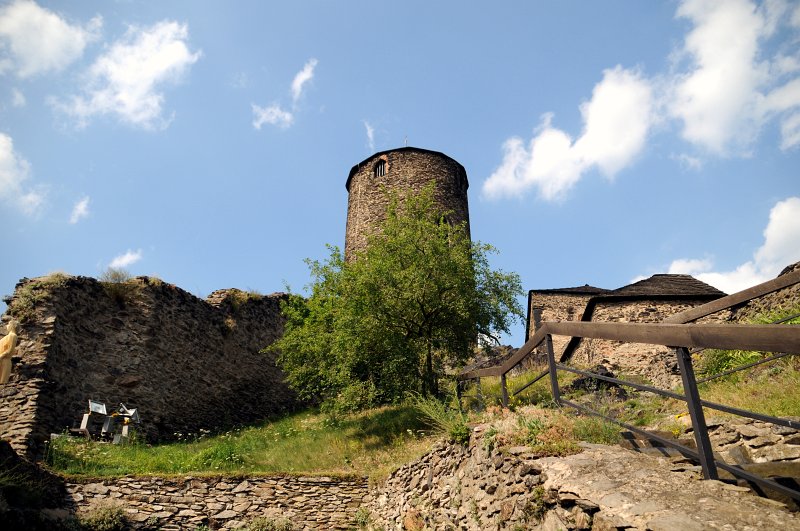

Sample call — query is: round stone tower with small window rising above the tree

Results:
[344,147,469,260]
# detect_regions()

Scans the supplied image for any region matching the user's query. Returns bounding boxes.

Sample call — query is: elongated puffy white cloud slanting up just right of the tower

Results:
[483,66,655,200]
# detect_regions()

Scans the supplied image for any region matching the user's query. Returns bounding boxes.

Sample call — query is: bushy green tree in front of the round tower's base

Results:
[270,188,522,408]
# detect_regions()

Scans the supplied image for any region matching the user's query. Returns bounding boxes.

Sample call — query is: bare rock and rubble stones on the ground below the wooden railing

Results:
[366,423,800,531]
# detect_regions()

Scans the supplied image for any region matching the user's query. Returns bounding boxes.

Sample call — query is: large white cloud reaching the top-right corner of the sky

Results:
[668,0,800,156]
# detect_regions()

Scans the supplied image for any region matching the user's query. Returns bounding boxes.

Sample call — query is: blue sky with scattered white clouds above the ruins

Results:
[0,0,800,344]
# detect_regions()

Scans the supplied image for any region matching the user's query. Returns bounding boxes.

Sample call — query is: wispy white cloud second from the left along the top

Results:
[54,20,201,129]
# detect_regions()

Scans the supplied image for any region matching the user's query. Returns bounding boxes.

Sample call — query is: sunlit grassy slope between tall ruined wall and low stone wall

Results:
[48,406,433,479]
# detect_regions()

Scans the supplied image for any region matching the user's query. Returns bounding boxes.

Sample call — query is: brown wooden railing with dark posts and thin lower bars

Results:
[458,270,800,500]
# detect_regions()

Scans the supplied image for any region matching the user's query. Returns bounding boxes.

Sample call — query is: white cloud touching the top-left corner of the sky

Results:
[0,0,103,78]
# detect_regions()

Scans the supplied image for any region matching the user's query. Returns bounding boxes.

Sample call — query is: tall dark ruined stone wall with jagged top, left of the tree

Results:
[0,277,297,456]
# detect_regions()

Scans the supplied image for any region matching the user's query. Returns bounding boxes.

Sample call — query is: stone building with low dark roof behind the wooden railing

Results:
[528,274,730,387]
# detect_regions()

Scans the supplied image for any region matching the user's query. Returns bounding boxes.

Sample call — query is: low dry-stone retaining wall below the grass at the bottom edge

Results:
[66,476,368,531]
